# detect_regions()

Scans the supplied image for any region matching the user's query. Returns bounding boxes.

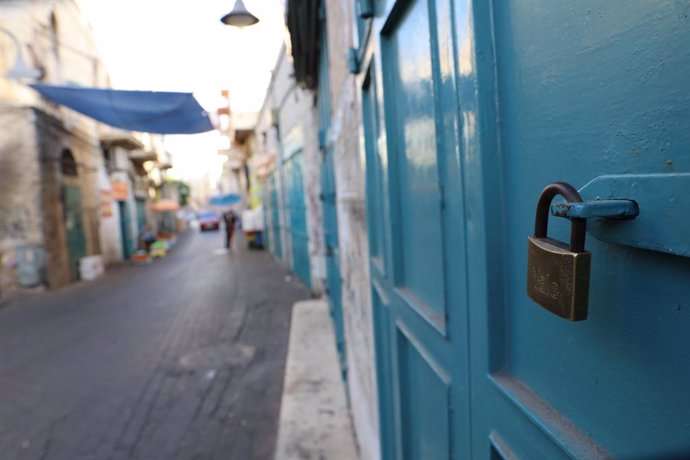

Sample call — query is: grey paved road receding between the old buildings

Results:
[0,233,306,460]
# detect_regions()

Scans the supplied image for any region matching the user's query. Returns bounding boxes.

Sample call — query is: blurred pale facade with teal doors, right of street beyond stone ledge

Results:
[253,48,325,294]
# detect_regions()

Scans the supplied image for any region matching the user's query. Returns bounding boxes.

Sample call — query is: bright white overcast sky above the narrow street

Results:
[77,0,285,183]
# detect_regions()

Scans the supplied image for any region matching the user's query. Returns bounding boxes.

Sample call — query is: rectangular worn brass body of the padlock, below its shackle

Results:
[527,236,592,321]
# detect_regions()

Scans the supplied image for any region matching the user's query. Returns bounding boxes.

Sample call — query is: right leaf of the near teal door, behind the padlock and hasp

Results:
[459,0,690,458]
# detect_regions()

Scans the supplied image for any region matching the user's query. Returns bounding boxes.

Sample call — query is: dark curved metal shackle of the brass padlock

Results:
[534,182,587,252]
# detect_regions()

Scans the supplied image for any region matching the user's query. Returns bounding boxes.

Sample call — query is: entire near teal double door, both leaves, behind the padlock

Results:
[360,0,690,459]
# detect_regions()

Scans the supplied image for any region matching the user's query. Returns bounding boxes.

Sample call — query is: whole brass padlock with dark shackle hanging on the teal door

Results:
[527,182,592,321]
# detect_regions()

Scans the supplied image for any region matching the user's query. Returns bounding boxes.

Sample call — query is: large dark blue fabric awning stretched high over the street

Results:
[30,84,214,134]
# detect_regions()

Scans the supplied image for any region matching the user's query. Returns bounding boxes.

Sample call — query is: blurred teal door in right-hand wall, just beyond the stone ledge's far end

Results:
[284,150,311,288]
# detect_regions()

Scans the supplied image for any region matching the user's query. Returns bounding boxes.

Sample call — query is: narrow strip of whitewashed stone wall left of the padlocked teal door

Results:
[326,0,380,460]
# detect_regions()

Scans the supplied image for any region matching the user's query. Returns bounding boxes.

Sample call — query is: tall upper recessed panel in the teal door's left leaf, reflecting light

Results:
[382,1,445,328]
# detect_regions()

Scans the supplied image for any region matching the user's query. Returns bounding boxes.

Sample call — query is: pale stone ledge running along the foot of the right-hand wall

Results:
[275,300,359,460]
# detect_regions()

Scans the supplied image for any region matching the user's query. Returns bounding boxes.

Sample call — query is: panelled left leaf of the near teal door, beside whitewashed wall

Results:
[362,0,470,459]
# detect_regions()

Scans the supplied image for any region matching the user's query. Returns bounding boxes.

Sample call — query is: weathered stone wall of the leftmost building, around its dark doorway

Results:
[0,0,108,287]
